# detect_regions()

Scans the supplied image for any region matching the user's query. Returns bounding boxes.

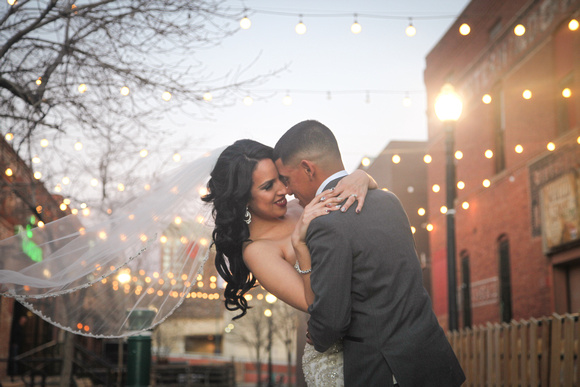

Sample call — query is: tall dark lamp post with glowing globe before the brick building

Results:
[435,83,463,331]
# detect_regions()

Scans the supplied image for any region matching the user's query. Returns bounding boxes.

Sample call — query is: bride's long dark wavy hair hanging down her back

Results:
[202,140,273,319]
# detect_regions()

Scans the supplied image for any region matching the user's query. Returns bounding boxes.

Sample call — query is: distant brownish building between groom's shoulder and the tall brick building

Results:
[359,141,431,293]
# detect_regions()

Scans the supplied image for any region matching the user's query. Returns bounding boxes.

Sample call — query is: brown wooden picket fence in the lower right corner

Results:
[448,314,580,387]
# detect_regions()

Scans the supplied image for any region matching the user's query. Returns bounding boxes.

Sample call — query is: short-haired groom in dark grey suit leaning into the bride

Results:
[274,121,465,387]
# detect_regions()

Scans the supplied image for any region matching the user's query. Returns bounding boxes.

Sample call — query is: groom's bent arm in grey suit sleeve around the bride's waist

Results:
[306,218,352,352]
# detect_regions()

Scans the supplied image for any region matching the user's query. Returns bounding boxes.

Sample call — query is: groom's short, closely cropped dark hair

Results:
[274,120,341,165]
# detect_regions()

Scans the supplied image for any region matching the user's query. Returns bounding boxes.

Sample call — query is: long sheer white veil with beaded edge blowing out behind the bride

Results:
[0,148,223,338]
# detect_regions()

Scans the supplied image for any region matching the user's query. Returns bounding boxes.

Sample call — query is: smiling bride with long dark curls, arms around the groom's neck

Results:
[202,140,377,386]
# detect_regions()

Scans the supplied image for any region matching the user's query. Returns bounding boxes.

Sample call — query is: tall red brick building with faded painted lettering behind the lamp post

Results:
[424,0,580,327]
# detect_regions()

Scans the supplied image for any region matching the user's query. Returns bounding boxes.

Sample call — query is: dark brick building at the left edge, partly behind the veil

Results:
[0,138,66,380]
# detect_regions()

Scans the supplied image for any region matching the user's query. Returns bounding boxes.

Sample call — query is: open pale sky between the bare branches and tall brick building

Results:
[171,0,468,170]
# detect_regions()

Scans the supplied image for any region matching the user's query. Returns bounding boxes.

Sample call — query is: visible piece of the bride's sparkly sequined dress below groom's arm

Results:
[302,342,344,387]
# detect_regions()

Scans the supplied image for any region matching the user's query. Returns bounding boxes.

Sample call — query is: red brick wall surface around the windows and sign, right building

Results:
[425,0,580,326]
